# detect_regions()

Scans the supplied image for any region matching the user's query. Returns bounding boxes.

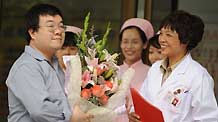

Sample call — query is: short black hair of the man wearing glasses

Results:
[25,3,63,43]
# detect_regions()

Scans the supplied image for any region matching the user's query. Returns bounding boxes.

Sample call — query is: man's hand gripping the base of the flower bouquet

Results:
[70,105,94,122]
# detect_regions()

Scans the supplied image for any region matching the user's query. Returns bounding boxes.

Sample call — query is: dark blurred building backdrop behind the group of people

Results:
[0,0,218,122]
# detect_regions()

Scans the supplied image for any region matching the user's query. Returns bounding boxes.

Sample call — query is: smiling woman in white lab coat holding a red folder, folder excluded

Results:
[129,11,218,122]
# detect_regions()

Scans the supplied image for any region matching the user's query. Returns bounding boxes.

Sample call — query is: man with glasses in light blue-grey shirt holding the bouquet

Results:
[6,4,92,122]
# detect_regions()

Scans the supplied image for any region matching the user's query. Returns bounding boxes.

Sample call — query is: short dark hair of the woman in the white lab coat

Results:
[160,10,204,51]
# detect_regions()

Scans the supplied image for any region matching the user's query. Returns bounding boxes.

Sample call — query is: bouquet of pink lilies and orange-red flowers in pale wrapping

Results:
[66,14,134,122]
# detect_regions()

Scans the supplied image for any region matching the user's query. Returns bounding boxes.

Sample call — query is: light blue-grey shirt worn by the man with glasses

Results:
[6,46,72,122]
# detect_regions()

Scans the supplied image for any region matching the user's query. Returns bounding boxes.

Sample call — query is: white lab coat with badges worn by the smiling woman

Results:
[140,54,218,122]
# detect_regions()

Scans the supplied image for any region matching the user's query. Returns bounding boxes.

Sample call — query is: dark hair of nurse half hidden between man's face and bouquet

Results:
[63,32,77,47]
